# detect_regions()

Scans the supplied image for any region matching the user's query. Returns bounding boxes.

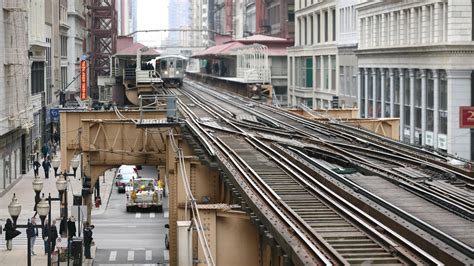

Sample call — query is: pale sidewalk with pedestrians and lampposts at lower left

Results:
[0,153,115,266]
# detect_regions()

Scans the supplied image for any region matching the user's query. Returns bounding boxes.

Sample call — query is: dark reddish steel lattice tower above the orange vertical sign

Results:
[84,0,117,100]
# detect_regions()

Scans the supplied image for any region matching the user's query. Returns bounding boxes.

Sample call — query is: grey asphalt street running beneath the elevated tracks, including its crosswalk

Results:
[92,166,169,265]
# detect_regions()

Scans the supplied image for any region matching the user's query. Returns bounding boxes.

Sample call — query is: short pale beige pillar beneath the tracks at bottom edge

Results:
[177,221,193,266]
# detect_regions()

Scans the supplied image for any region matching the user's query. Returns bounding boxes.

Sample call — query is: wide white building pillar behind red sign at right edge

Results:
[447,70,472,160]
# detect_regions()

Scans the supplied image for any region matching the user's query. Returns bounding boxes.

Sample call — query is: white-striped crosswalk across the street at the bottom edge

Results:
[94,248,169,265]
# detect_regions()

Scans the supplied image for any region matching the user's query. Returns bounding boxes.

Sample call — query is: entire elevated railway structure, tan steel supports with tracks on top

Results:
[61,78,474,265]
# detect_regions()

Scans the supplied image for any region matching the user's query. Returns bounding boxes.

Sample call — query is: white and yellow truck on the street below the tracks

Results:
[125,177,163,212]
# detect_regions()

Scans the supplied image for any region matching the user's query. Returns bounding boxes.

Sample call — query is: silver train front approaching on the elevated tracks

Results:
[155,55,188,87]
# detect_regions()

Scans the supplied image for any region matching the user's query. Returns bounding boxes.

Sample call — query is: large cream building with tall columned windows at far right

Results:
[356,0,474,159]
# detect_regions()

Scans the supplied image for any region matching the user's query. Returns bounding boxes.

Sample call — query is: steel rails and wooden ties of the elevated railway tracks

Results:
[171,80,474,264]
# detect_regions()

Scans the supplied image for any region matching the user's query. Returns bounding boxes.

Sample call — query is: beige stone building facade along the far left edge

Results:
[0,0,34,190]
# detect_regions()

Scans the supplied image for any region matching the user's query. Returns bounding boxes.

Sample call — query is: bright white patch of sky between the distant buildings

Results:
[136,0,169,46]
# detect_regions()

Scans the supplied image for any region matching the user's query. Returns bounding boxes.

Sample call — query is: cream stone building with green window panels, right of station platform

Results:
[288,0,339,108]
